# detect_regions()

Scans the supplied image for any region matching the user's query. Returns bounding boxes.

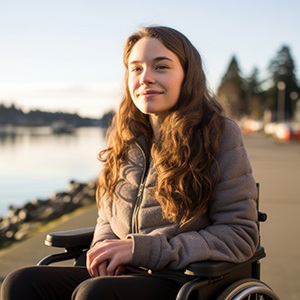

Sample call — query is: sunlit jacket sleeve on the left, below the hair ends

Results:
[91,199,118,247]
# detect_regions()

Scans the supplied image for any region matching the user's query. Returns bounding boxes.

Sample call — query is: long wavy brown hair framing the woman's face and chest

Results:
[97,26,224,224]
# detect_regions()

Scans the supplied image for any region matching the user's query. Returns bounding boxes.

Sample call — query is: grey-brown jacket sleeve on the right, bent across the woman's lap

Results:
[128,120,258,270]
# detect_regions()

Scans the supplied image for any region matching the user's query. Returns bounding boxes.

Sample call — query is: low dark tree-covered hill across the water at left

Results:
[0,103,114,128]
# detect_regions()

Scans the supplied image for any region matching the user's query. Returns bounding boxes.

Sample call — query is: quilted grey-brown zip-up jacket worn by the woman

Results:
[92,119,258,271]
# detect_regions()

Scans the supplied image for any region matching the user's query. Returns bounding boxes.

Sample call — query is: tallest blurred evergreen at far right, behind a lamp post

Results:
[268,46,300,121]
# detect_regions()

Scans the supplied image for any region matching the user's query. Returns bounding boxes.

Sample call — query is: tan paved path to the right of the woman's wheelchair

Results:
[245,136,300,300]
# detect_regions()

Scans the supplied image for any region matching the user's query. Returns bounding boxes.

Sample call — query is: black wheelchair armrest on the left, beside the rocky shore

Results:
[45,227,95,249]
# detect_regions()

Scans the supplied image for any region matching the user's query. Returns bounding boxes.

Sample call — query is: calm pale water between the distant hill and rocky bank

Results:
[0,127,105,216]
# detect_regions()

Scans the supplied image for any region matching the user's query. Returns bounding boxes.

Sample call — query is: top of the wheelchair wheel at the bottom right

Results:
[217,278,280,300]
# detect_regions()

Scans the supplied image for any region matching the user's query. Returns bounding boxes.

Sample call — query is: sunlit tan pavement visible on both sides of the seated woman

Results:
[0,135,300,300]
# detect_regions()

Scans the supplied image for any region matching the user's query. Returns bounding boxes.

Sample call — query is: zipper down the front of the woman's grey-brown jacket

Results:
[131,142,149,233]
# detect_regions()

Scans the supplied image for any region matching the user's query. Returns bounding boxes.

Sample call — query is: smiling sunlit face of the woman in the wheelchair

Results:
[128,37,184,117]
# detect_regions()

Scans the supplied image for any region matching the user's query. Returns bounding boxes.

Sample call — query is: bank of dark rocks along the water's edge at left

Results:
[0,180,97,248]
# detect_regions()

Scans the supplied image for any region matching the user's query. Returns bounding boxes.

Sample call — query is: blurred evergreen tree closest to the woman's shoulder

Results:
[217,55,247,119]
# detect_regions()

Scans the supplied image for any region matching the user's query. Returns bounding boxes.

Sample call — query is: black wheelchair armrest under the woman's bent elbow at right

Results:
[185,246,266,277]
